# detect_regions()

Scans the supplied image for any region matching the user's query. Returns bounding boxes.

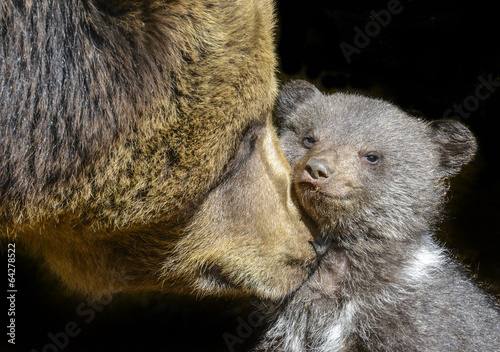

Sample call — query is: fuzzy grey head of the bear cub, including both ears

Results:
[276,81,476,240]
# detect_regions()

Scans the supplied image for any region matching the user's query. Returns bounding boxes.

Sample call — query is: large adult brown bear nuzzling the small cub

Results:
[0,0,316,298]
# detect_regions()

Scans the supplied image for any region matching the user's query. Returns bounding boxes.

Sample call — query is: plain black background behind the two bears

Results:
[0,0,500,352]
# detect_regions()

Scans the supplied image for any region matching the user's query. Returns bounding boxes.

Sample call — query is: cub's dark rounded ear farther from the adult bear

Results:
[429,120,477,176]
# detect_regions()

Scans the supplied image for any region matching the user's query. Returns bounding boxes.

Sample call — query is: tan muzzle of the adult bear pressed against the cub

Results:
[164,121,316,299]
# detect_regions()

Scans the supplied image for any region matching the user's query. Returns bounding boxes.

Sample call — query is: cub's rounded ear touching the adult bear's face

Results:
[274,79,321,125]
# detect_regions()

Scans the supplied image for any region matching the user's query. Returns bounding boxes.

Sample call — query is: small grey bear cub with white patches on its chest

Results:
[254,81,500,352]
